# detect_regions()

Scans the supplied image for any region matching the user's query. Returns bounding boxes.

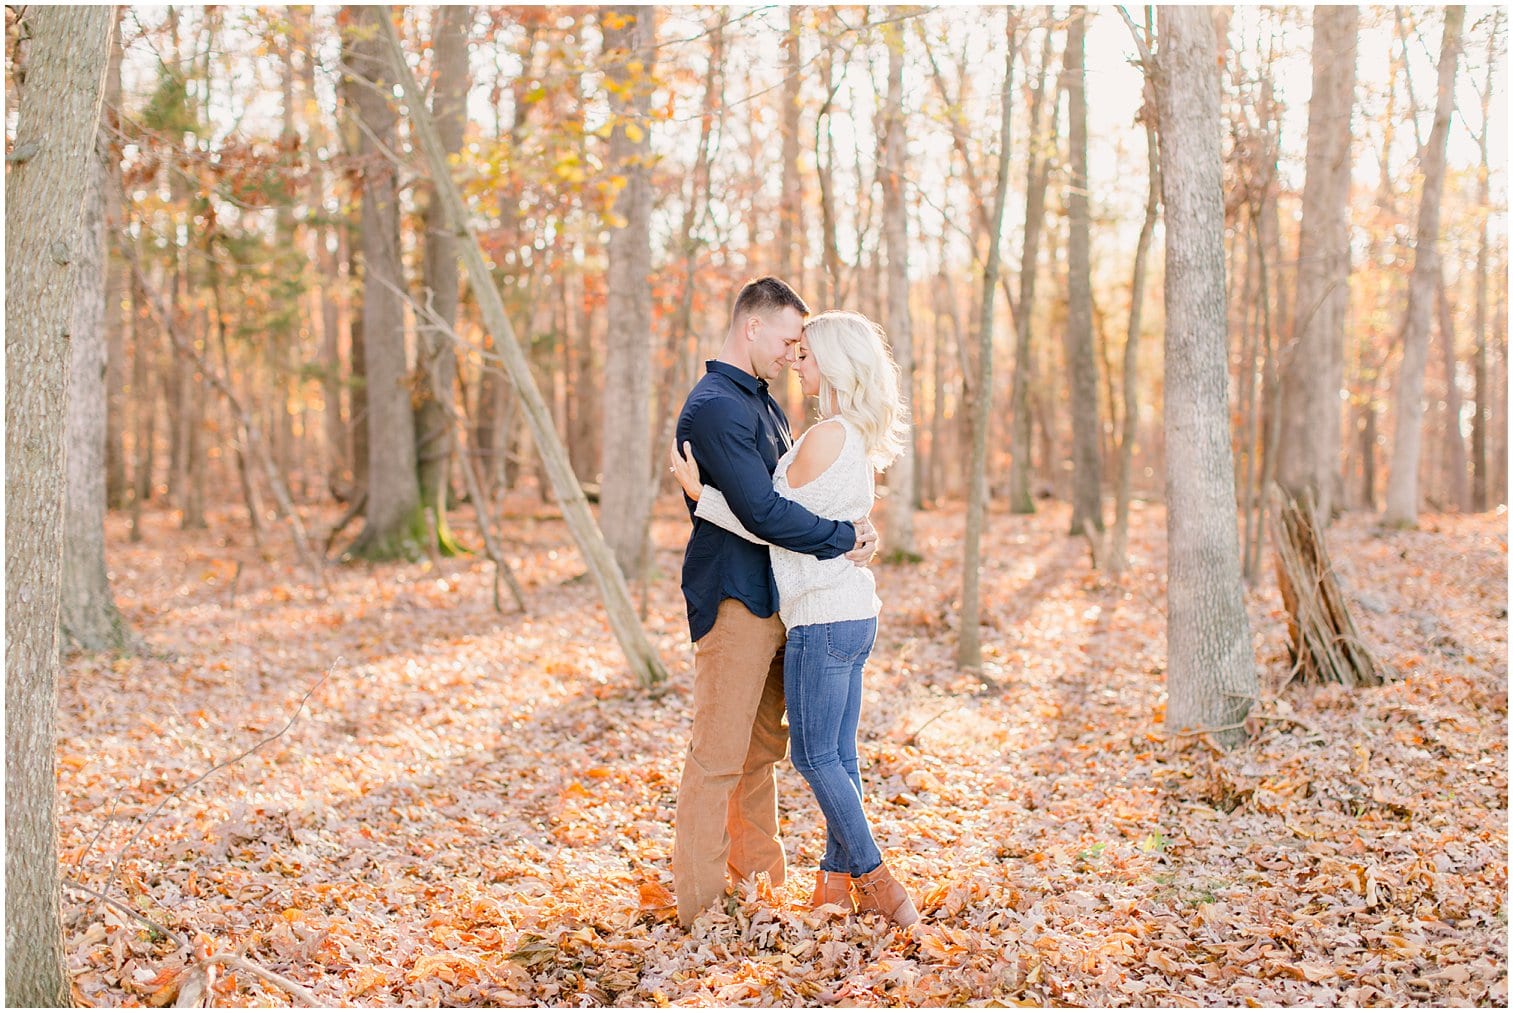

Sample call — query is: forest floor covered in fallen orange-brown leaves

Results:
[59,497,1508,1007]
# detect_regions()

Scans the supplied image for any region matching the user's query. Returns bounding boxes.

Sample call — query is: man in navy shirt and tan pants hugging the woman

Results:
[672,278,878,928]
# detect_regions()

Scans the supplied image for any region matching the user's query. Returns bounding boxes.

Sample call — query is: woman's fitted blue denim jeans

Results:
[782,618,882,875]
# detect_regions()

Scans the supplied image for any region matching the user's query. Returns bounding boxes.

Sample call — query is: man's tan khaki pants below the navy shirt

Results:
[672,599,788,928]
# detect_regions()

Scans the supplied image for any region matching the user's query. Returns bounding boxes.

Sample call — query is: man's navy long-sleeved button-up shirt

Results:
[676,360,856,643]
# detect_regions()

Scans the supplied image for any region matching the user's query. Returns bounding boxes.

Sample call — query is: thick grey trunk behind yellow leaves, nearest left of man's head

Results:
[599,6,657,581]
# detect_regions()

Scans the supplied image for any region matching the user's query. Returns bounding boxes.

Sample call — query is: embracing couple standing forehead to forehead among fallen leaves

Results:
[672,278,918,928]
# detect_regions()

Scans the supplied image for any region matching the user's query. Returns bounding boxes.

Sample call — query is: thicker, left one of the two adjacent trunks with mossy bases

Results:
[348,8,427,559]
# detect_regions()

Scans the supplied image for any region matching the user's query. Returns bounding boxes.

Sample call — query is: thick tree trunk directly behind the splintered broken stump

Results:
[1277,6,1359,525]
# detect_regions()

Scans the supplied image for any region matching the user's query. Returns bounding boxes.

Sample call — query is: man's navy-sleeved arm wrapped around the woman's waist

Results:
[688,398,856,559]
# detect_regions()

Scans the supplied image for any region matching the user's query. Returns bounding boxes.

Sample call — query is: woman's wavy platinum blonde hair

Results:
[803,310,909,472]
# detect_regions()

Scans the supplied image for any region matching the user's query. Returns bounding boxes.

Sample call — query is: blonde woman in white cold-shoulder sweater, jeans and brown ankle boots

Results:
[672,313,920,927]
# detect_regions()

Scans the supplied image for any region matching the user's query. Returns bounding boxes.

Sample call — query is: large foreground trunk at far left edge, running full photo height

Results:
[5,6,112,1008]
